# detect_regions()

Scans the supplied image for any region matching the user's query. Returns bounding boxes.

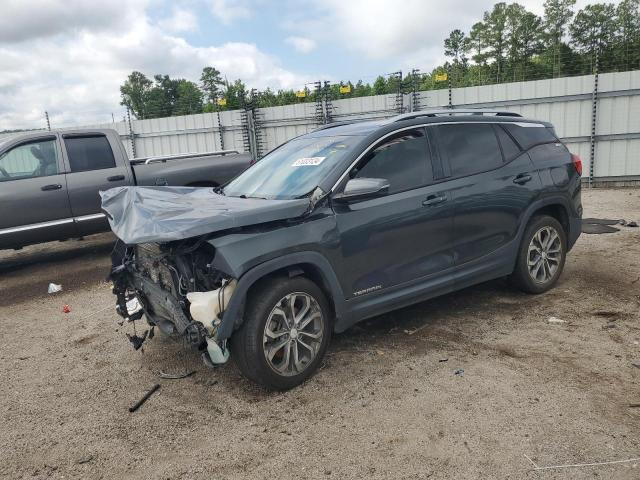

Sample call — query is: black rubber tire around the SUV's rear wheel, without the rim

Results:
[510,215,567,294]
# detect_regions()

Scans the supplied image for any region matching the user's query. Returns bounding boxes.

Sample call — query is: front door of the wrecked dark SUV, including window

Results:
[333,127,453,298]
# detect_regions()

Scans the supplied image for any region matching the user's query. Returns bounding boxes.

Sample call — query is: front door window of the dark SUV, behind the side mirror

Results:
[351,129,433,193]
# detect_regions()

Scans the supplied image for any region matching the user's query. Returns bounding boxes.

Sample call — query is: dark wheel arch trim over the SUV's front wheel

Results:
[216,251,346,341]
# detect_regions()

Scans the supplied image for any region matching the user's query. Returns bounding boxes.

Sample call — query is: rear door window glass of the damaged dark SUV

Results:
[437,123,503,177]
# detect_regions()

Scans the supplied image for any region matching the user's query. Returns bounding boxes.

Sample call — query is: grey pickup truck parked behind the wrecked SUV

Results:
[0,129,251,249]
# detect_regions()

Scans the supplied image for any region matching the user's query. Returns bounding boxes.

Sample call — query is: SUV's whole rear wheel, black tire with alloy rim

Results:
[511,215,567,294]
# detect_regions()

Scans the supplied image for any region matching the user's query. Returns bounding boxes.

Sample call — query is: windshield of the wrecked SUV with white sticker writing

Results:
[224,136,360,200]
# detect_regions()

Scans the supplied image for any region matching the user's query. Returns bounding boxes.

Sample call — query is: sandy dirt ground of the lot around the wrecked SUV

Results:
[0,189,640,479]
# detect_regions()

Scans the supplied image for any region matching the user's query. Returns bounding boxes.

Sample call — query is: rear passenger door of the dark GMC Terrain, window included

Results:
[435,122,540,268]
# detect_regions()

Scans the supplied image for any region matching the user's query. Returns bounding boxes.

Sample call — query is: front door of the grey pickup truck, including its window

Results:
[0,134,75,248]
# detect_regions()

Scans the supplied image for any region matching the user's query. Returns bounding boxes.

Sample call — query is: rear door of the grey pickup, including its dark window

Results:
[62,133,131,235]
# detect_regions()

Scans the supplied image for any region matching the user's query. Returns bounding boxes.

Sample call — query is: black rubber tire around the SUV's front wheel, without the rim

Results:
[230,276,333,390]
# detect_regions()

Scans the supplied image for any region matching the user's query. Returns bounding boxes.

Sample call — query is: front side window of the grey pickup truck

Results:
[0,138,58,182]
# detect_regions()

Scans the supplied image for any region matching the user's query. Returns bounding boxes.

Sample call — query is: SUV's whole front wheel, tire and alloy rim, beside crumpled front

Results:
[230,277,332,390]
